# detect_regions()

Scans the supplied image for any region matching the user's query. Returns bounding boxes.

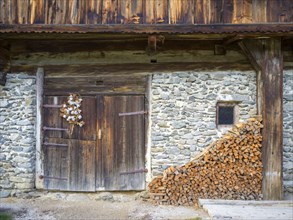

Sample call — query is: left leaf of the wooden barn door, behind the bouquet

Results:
[43,96,97,191]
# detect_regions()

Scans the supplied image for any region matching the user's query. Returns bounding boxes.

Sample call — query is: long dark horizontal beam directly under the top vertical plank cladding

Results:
[0,22,293,36]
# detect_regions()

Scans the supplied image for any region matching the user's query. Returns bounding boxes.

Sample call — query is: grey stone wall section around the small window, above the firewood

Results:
[151,71,256,176]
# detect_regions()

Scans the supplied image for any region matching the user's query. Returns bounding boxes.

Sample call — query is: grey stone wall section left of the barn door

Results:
[0,73,36,197]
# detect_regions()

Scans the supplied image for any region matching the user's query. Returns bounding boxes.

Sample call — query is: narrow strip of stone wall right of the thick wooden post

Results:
[283,70,293,199]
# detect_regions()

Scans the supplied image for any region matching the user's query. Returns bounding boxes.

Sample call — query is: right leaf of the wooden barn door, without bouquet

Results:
[96,95,145,190]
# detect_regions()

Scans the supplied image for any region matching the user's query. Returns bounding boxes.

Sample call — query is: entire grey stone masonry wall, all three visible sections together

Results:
[0,70,293,198]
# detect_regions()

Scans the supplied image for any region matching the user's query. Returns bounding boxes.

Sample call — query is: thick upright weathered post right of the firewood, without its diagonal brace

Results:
[262,39,283,200]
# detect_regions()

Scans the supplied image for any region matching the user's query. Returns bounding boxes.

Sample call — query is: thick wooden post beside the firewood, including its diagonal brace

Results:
[239,38,283,200]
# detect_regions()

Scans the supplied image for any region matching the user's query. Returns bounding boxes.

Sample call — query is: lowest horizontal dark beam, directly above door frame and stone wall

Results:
[36,62,251,79]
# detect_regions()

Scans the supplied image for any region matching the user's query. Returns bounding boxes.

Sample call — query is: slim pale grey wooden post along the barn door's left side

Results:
[35,67,44,189]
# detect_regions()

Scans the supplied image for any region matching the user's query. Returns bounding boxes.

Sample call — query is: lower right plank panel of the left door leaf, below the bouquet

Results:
[68,139,96,191]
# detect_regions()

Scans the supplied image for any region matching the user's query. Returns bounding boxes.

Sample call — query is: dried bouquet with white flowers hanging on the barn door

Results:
[60,93,84,134]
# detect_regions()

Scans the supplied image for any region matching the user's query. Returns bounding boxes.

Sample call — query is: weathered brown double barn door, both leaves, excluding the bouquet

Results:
[43,95,145,191]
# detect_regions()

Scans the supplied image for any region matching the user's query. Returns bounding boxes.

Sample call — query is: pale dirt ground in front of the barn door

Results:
[0,193,210,220]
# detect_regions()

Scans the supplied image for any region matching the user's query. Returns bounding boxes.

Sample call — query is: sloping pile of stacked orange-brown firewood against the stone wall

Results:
[148,118,262,205]
